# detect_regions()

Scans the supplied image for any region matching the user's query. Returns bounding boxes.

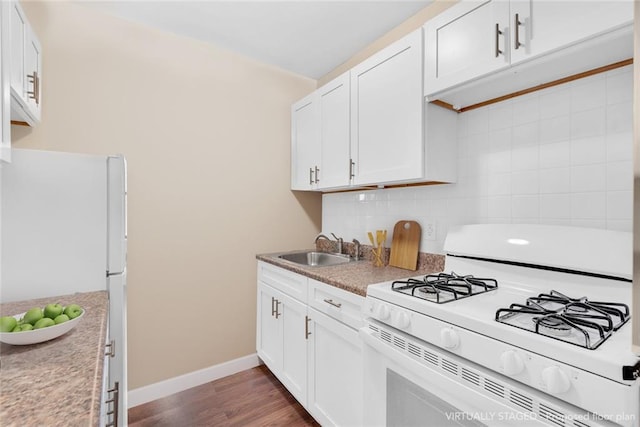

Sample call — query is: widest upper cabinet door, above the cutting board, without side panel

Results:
[351,29,424,185]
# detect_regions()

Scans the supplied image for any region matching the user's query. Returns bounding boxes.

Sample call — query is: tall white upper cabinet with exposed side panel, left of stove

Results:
[351,29,456,186]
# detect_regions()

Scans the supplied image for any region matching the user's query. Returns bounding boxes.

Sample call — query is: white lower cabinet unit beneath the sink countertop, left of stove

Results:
[256,261,364,426]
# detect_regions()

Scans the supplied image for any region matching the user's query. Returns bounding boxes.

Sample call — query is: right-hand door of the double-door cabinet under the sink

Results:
[278,294,309,407]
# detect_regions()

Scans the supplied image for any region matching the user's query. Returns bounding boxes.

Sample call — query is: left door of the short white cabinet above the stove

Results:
[424,0,510,96]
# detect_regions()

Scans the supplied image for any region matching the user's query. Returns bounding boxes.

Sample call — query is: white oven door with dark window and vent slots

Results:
[360,320,551,427]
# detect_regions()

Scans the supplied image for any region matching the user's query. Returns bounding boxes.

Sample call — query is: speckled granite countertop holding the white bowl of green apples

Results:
[0,291,108,427]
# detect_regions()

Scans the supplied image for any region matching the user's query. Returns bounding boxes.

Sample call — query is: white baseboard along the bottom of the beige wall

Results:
[127,353,262,408]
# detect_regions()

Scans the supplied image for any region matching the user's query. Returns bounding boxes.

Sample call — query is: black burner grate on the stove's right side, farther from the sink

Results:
[495,291,631,350]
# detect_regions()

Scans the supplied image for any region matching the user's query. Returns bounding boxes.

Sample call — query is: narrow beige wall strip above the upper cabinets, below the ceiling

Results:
[318,0,458,87]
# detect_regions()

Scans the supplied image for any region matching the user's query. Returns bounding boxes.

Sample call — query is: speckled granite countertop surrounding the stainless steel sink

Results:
[256,246,444,296]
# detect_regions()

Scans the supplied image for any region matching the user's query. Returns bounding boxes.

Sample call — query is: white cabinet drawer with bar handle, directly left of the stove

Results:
[309,279,364,329]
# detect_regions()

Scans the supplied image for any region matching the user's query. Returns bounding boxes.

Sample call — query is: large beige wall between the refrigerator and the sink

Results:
[12,1,321,389]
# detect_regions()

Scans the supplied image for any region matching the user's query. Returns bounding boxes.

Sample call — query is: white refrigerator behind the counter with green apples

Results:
[0,149,127,426]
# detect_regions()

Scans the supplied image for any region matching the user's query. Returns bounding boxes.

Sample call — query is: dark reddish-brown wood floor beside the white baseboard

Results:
[129,365,320,427]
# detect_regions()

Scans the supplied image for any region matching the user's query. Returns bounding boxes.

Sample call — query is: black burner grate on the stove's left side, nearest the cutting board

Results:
[391,271,498,304]
